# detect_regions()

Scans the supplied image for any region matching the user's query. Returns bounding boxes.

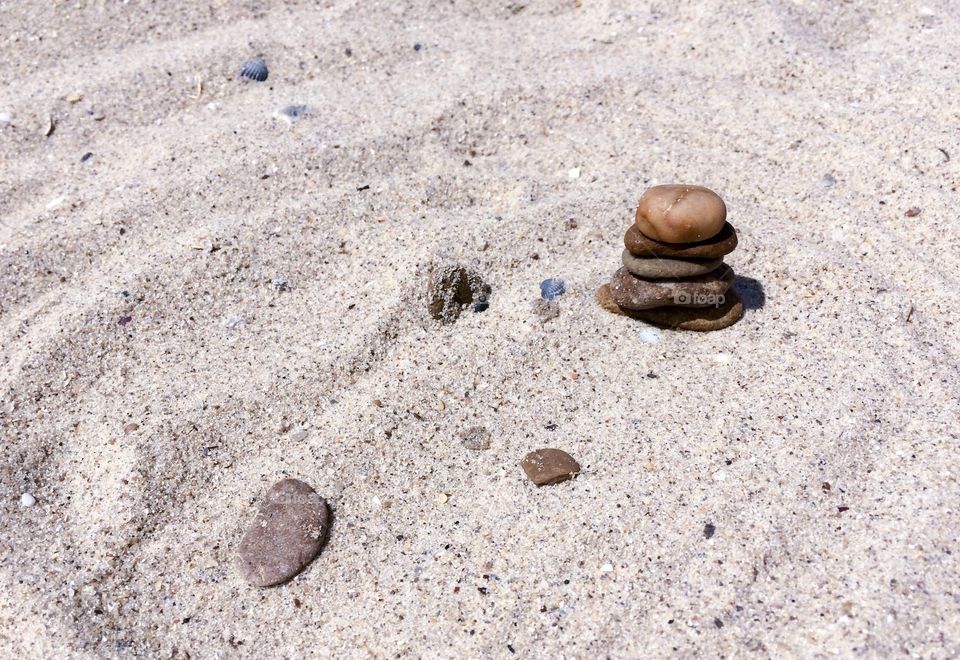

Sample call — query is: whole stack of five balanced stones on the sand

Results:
[597,184,743,331]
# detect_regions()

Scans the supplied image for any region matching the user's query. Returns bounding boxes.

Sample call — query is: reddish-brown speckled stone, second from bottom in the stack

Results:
[610,264,734,309]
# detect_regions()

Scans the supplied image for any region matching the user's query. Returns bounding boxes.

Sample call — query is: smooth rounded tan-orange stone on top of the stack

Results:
[636,183,727,243]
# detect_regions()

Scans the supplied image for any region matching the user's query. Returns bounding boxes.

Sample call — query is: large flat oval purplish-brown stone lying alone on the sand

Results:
[237,479,330,587]
